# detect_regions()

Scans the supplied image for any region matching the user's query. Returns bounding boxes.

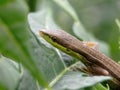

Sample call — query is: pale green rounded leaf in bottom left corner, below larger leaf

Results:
[0,57,21,90]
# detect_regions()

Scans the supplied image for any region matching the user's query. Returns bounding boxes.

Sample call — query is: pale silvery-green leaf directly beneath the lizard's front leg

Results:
[54,71,110,90]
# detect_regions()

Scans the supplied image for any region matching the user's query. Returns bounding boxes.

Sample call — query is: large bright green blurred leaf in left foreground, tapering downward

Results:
[0,0,49,88]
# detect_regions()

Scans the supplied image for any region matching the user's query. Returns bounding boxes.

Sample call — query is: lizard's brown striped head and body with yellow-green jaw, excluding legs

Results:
[40,30,120,82]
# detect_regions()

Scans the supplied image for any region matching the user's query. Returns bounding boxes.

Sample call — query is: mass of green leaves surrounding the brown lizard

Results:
[0,0,120,90]
